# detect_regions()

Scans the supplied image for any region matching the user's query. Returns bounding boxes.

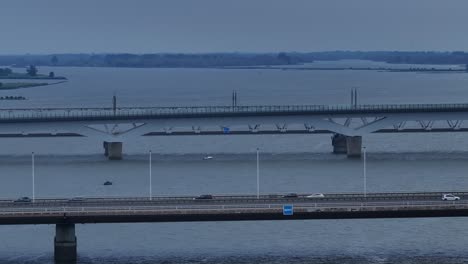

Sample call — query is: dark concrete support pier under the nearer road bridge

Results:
[54,224,77,262]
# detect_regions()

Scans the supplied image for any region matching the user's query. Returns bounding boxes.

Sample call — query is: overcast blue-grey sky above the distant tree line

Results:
[0,0,468,55]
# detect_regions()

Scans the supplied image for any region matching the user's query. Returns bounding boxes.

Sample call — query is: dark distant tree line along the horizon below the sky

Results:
[0,51,468,69]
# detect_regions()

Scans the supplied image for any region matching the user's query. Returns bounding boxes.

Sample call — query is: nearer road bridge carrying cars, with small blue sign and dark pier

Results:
[0,192,468,261]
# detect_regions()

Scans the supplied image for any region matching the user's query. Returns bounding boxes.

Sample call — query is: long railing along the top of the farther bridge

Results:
[0,104,468,122]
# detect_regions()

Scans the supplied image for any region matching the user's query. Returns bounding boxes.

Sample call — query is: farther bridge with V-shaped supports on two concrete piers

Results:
[0,104,468,159]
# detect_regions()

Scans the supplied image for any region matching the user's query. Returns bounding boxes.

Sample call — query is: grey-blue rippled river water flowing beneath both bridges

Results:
[0,61,468,264]
